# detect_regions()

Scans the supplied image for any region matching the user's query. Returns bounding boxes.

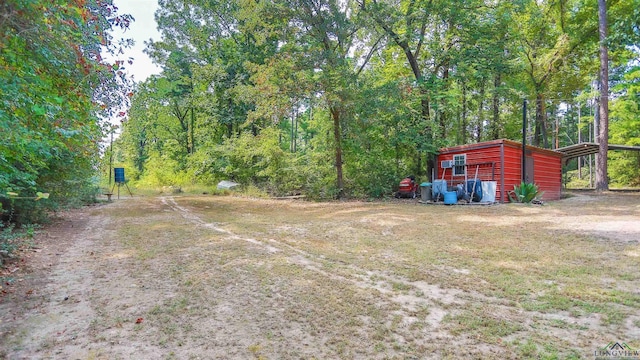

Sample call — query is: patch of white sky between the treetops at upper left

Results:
[113,0,161,82]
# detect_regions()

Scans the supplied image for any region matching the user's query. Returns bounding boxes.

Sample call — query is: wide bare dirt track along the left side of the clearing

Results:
[0,204,166,359]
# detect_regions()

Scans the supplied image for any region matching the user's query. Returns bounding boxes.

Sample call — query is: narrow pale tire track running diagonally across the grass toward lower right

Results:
[161,197,632,352]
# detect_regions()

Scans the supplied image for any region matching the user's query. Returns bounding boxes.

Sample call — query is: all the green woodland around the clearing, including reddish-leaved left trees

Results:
[0,0,640,222]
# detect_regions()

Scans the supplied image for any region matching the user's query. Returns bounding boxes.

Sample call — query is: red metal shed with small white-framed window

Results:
[435,139,563,202]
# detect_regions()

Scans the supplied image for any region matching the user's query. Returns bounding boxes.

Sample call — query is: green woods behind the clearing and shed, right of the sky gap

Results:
[114,0,640,198]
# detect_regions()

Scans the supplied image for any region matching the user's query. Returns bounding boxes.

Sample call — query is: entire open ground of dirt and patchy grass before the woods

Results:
[0,193,640,359]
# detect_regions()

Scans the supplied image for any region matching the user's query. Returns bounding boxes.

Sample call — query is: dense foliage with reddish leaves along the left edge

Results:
[0,0,133,225]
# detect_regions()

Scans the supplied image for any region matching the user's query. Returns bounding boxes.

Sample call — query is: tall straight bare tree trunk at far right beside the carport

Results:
[596,0,609,191]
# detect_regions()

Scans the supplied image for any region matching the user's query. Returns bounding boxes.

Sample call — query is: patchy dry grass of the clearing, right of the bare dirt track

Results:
[82,191,640,359]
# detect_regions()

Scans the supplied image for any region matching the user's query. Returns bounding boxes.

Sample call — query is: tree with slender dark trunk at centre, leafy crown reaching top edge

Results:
[242,0,378,197]
